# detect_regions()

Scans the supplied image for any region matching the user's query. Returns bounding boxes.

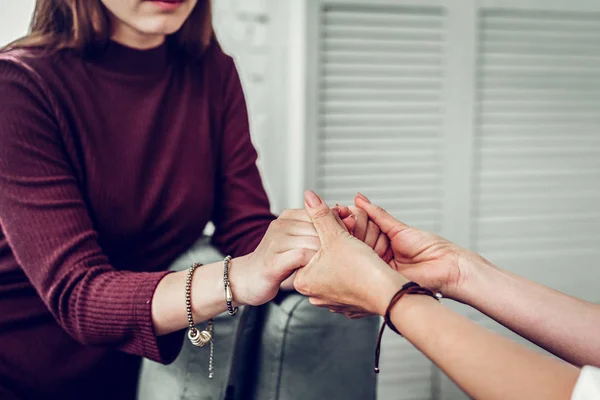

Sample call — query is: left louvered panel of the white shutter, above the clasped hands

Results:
[315,1,445,400]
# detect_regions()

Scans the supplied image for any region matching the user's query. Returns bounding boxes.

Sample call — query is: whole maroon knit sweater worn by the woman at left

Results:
[0,43,273,399]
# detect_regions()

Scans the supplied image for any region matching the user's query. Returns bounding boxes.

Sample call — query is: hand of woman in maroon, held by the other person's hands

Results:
[229,210,321,306]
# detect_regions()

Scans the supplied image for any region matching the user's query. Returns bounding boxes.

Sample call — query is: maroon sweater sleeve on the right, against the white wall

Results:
[213,56,275,257]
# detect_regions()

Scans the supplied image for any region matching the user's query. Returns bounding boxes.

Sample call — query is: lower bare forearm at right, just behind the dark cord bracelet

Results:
[392,295,579,400]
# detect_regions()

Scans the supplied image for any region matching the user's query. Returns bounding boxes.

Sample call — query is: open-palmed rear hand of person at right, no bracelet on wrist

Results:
[355,194,483,301]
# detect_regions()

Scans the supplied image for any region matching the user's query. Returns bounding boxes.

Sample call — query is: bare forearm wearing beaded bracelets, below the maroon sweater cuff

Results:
[152,257,247,336]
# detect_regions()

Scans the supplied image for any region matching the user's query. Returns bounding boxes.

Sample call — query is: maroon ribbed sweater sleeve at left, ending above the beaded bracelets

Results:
[0,57,183,363]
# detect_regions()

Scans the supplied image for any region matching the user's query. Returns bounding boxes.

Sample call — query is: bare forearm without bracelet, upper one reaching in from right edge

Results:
[461,260,600,366]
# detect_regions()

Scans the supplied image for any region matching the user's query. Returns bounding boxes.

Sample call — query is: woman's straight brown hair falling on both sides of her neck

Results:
[5,0,213,57]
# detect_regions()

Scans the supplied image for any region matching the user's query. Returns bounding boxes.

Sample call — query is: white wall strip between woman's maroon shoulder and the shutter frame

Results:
[213,0,294,212]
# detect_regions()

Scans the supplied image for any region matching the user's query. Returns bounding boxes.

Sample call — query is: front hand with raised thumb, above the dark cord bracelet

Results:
[294,191,407,315]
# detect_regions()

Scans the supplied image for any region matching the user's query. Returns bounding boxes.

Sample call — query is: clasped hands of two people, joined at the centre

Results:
[234,191,480,318]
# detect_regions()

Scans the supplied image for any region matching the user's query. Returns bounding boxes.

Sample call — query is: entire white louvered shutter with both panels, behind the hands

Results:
[307,0,600,400]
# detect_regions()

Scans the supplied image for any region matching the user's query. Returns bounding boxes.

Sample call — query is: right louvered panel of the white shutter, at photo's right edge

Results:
[442,0,600,400]
